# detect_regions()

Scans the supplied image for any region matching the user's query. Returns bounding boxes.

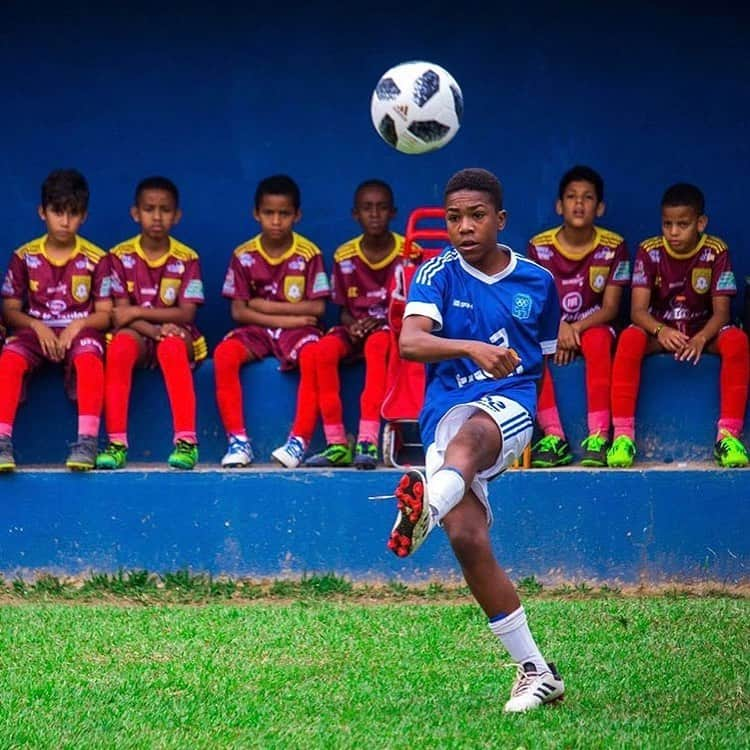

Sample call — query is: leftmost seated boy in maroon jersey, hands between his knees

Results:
[0,169,112,471]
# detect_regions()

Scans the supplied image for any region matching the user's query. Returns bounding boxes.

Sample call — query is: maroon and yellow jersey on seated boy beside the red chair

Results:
[331,232,404,321]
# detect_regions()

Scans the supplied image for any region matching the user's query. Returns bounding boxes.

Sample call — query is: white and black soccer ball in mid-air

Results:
[370,60,464,154]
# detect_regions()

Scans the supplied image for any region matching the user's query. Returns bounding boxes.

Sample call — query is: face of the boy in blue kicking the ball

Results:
[445,190,506,266]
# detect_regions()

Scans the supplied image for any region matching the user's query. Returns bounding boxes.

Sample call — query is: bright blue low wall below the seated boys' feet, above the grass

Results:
[0,469,750,584]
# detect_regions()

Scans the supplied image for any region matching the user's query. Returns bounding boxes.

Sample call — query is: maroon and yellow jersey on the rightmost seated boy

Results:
[633,234,737,336]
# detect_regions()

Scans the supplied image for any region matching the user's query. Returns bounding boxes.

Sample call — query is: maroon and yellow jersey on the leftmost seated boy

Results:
[2,234,110,328]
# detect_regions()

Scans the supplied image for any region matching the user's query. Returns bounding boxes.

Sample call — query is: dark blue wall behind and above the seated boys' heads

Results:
[0,0,750,345]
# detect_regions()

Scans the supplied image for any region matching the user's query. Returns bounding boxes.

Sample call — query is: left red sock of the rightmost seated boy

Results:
[612,326,648,440]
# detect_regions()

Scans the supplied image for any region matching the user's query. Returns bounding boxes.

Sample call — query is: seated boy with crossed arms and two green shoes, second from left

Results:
[96,177,207,469]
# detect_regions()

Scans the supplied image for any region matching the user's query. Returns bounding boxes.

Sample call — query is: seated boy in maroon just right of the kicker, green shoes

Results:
[527,166,630,468]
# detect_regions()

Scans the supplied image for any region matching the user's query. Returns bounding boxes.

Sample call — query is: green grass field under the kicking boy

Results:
[0,596,750,750]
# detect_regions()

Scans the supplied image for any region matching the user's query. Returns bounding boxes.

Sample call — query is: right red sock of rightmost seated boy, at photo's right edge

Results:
[716,327,750,437]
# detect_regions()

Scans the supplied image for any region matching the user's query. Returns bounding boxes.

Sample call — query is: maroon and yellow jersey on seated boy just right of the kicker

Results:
[526,227,630,323]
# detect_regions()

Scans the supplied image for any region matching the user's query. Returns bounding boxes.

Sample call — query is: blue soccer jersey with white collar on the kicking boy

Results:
[404,245,560,446]
